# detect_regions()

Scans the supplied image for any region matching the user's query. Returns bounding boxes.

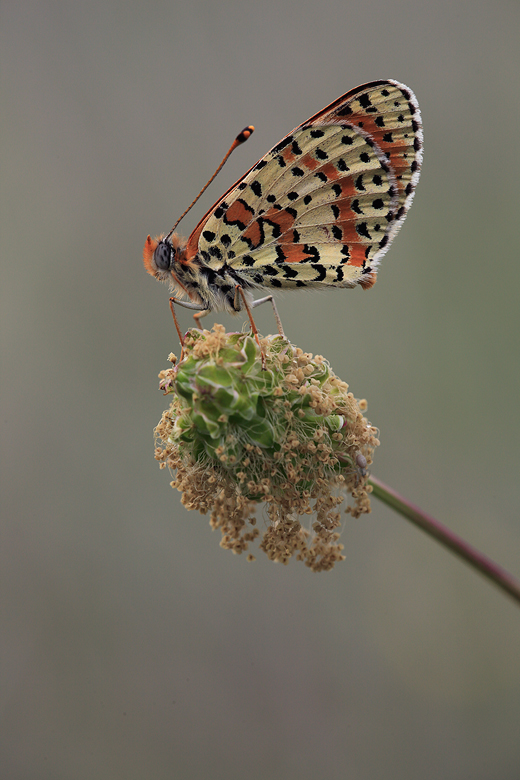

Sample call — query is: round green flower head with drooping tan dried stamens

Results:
[155,325,379,571]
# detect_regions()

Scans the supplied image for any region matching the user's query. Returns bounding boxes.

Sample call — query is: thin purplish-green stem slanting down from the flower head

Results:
[369,477,520,604]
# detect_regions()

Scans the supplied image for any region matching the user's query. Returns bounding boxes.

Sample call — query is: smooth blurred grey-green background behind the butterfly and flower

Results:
[0,0,520,780]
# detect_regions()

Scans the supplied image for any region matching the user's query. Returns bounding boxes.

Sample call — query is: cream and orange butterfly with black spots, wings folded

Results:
[143,80,423,343]
